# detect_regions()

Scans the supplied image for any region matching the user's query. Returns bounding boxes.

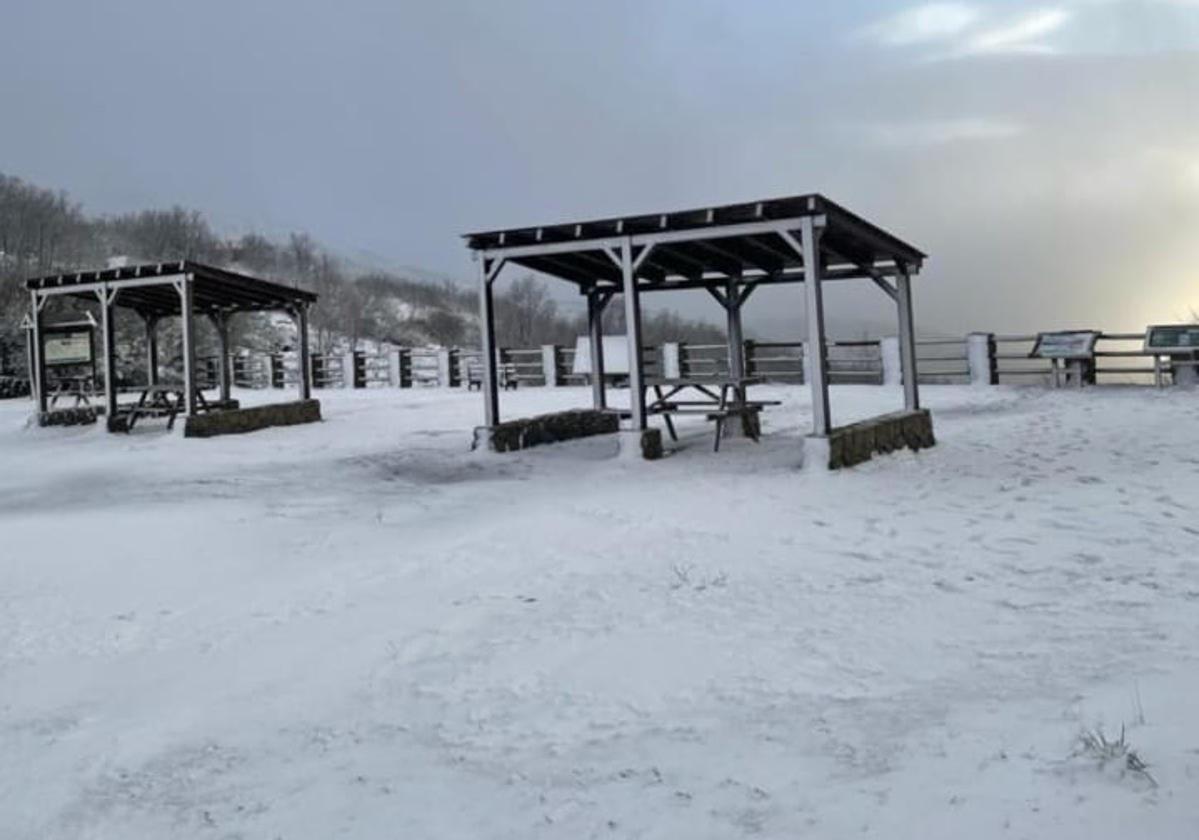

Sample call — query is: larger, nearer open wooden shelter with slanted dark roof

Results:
[465,194,924,437]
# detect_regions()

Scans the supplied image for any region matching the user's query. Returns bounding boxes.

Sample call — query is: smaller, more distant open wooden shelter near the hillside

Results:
[25,260,317,426]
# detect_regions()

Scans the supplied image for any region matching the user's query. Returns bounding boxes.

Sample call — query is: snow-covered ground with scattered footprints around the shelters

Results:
[0,387,1199,840]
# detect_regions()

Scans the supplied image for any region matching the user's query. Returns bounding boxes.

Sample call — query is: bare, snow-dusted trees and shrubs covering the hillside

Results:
[0,174,723,370]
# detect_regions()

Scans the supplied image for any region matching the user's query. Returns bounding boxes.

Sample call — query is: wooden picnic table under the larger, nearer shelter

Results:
[645,376,779,452]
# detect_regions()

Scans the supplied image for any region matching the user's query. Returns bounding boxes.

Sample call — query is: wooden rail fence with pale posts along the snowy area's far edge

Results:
[11,333,1199,398]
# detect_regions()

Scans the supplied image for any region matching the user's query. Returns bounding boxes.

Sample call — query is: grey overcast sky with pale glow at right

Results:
[0,0,1199,333]
